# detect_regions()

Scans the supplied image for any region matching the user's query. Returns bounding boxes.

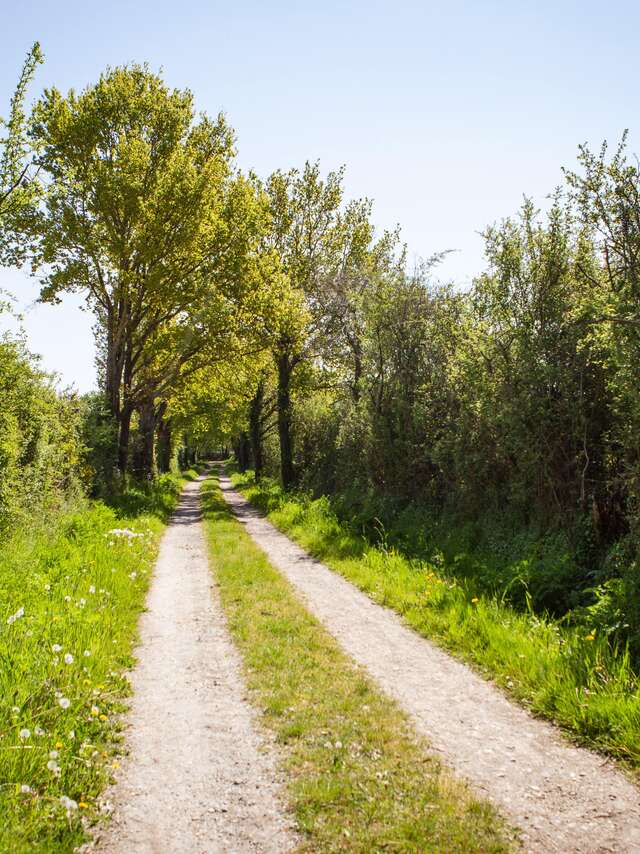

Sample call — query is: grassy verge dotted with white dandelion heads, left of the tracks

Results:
[0,475,186,852]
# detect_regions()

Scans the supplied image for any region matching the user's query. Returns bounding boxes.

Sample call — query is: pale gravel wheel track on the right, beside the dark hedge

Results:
[221,477,640,854]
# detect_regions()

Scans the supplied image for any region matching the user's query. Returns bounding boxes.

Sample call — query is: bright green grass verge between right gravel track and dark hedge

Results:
[233,474,640,773]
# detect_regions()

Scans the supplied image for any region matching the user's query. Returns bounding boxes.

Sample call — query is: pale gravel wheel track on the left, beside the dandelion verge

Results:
[97,474,294,854]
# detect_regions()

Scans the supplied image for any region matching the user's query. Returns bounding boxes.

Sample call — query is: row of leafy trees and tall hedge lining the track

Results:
[0,47,640,636]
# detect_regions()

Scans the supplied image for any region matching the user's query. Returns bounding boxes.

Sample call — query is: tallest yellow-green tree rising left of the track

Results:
[31,65,233,472]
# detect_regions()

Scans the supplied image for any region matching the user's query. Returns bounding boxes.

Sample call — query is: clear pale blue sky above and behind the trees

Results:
[0,0,640,390]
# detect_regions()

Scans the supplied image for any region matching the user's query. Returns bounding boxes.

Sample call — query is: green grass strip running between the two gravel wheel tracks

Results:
[203,481,512,852]
